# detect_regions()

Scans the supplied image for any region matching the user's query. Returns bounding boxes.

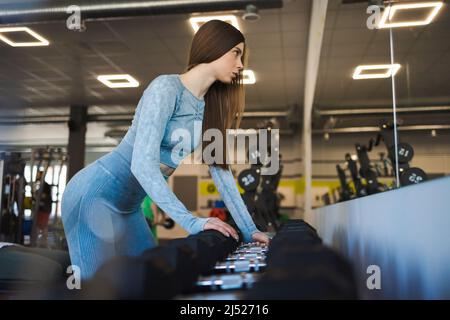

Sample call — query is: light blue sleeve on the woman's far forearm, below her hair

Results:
[209,165,260,242]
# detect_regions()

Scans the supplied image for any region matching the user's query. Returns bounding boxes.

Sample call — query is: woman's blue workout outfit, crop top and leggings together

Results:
[61,74,258,279]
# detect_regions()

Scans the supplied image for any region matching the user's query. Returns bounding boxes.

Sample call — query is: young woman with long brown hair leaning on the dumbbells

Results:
[62,20,269,279]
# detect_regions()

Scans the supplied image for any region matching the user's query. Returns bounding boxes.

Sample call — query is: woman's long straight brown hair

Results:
[187,20,247,169]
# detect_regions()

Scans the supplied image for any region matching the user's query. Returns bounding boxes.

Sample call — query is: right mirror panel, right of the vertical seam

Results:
[386,1,450,187]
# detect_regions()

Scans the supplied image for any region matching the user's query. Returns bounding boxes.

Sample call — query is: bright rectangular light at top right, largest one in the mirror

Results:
[378,1,443,29]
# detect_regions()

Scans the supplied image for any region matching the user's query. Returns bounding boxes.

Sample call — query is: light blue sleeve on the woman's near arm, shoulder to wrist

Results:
[131,76,208,234]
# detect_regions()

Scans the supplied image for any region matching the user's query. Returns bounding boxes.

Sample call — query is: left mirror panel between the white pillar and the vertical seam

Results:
[312,1,393,207]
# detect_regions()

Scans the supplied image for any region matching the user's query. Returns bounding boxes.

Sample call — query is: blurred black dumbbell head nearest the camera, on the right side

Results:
[245,245,357,299]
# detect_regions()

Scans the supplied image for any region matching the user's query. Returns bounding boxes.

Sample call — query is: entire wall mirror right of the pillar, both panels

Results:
[312,1,450,207]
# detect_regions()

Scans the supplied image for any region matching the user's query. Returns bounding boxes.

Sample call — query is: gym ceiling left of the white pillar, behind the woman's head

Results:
[0,0,310,115]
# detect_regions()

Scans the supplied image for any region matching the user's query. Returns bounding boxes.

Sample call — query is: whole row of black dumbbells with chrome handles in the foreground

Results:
[16,220,356,300]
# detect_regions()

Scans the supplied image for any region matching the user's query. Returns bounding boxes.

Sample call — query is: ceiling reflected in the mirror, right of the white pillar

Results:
[315,1,450,108]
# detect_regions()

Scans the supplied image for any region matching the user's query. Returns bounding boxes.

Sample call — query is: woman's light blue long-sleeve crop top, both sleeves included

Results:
[113,74,258,242]
